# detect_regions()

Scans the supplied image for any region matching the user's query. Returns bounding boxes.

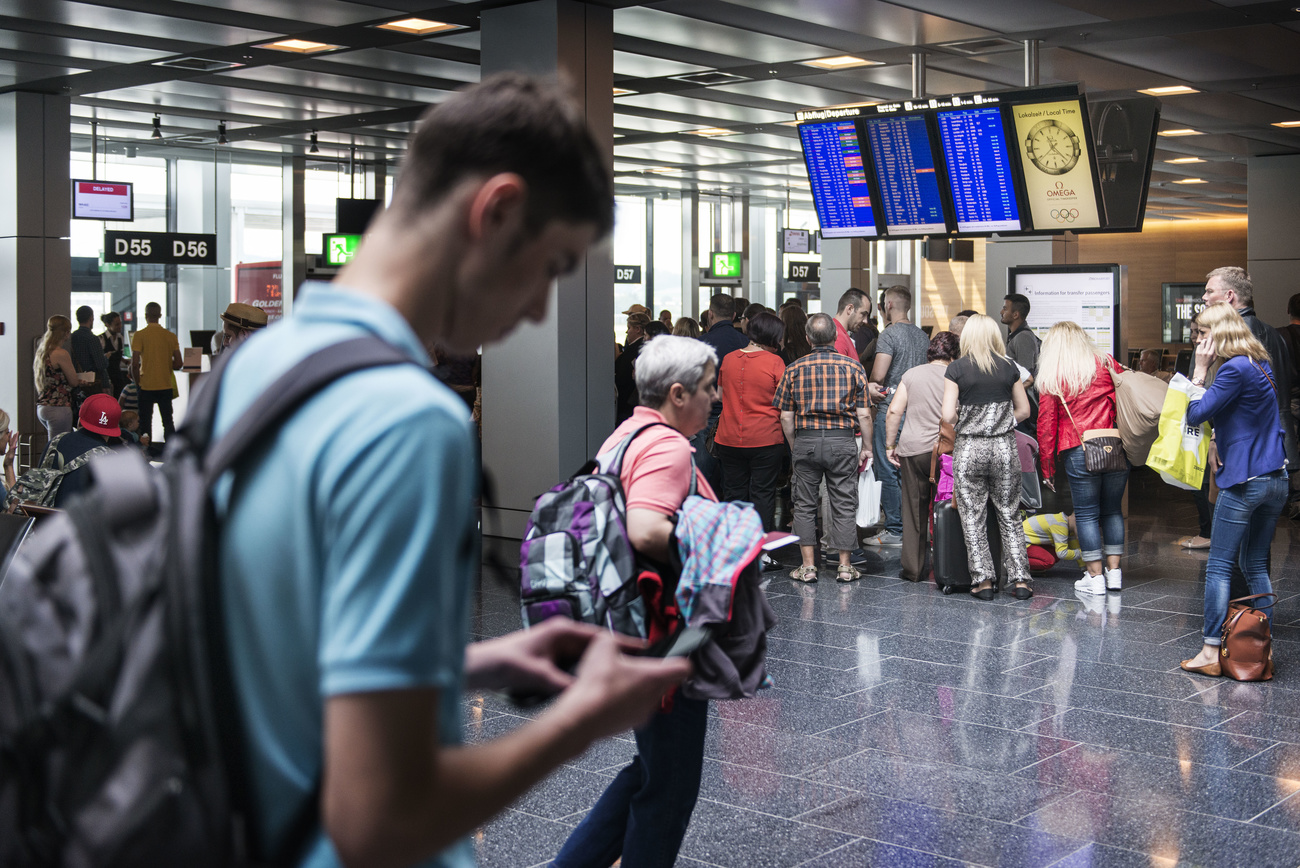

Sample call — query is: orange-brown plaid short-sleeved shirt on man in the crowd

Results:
[772,347,867,431]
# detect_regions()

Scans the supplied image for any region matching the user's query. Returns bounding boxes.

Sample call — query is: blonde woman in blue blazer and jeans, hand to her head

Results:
[1182,301,1287,676]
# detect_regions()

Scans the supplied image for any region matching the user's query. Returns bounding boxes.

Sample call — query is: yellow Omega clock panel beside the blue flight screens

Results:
[1011,99,1101,231]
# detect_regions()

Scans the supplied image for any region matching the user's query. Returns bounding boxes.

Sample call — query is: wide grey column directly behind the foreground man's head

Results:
[481,0,615,538]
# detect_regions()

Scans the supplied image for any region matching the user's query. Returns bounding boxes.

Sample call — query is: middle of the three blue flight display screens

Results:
[866,114,948,235]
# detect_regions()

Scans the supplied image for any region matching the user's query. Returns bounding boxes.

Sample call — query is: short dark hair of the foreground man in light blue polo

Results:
[391,73,614,235]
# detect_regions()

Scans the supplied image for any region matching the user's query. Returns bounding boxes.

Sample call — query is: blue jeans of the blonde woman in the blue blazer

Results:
[1201,470,1290,645]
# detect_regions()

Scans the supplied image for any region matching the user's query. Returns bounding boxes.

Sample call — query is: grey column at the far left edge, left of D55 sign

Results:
[0,92,72,434]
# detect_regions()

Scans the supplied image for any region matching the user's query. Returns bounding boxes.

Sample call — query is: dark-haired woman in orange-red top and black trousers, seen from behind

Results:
[714,313,787,530]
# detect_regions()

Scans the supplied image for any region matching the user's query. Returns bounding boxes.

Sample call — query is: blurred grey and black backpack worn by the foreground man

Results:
[0,338,410,868]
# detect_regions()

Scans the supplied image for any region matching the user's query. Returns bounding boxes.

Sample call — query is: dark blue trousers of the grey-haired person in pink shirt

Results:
[551,691,709,868]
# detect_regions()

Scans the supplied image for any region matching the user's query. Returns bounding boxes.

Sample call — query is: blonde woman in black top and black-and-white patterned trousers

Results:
[940,314,1034,600]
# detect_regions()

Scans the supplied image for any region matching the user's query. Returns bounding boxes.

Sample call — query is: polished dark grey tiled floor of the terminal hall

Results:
[467,477,1300,868]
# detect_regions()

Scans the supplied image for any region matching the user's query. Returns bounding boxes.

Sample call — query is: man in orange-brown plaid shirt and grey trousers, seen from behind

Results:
[772,313,871,582]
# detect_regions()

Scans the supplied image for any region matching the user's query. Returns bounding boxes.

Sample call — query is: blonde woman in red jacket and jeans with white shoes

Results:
[1035,321,1128,594]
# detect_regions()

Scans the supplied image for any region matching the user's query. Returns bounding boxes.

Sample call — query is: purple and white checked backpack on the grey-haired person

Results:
[519,422,696,638]
